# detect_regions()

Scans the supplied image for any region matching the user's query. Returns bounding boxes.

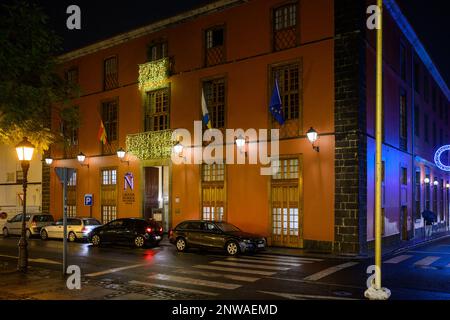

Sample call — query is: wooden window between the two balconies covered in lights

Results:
[144,88,170,131]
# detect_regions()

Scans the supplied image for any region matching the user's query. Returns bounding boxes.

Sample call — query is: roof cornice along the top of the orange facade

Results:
[58,0,248,63]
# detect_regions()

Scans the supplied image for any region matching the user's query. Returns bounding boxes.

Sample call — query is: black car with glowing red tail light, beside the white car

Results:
[89,218,163,248]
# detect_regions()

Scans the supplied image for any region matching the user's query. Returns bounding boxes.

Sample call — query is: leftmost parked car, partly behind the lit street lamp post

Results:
[2,213,54,238]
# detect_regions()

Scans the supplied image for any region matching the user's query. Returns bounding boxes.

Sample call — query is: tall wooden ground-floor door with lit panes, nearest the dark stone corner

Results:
[271,158,303,247]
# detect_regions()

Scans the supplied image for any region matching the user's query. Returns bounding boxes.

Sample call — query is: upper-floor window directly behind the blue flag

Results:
[270,63,301,138]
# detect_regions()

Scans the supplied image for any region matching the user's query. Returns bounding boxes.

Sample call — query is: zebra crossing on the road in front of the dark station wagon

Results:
[129,254,323,296]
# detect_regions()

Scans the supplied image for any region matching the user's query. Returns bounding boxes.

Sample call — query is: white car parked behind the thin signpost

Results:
[41,218,102,242]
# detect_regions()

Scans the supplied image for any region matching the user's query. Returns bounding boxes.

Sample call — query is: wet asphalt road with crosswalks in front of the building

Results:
[0,237,450,300]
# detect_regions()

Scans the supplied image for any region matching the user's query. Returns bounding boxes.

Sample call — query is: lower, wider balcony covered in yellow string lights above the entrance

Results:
[126,130,174,160]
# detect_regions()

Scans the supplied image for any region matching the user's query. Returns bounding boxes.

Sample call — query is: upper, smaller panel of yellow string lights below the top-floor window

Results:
[138,58,169,91]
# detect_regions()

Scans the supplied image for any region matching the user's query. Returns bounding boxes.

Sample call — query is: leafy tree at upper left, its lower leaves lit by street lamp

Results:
[0,0,79,152]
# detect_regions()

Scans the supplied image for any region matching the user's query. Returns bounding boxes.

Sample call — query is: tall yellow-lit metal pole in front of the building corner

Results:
[375,0,383,290]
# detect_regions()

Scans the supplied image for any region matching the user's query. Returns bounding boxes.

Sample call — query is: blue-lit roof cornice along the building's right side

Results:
[384,0,450,101]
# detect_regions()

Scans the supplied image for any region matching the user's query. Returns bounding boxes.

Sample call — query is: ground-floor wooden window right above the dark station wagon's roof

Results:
[202,163,226,221]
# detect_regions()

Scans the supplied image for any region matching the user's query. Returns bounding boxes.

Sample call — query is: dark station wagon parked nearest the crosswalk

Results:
[169,220,266,256]
